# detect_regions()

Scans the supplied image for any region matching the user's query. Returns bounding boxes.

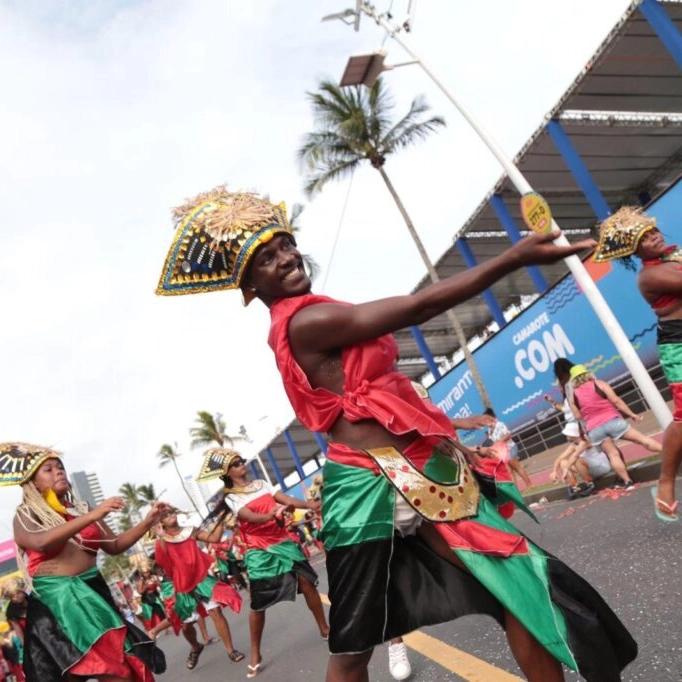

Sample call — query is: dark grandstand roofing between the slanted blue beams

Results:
[256,0,682,480]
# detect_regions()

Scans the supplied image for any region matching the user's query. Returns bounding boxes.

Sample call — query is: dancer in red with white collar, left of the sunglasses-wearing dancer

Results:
[154,509,244,670]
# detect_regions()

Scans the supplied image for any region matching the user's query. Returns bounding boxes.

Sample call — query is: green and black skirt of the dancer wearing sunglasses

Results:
[244,540,317,611]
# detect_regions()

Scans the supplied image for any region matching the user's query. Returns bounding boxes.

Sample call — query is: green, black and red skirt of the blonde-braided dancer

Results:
[24,568,166,682]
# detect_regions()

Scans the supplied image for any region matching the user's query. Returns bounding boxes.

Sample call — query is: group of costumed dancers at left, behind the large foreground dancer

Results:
[0,442,329,682]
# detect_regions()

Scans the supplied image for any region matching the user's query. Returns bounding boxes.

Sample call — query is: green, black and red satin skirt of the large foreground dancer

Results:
[322,438,637,682]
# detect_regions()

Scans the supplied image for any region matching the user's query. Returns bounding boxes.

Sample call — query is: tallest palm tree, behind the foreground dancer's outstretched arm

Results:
[298,79,490,407]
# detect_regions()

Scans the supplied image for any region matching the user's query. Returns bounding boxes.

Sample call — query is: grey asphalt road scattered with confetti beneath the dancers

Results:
[159,478,682,682]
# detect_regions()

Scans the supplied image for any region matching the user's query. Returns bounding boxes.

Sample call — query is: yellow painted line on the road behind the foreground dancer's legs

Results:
[320,593,523,682]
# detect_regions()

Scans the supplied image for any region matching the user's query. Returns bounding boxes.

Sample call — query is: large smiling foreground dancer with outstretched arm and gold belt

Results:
[157,188,637,682]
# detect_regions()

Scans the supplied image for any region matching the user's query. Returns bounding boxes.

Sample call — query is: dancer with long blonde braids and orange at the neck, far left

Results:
[0,443,167,682]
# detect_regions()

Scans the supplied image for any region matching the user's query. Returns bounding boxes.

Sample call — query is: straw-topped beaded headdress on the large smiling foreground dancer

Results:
[156,186,293,305]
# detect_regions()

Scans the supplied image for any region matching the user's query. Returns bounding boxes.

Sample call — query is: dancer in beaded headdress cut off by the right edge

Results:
[594,206,682,521]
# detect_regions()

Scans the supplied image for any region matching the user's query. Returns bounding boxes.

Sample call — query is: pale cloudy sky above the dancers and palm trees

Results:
[0,0,629,527]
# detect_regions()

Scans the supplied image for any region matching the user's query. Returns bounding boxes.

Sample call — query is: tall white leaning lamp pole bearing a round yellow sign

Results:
[360,2,672,429]
